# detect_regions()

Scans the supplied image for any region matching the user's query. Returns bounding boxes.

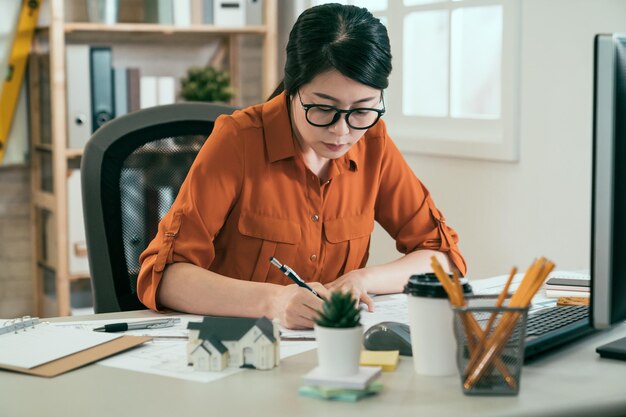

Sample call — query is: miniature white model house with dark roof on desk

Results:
[187,317,280,371]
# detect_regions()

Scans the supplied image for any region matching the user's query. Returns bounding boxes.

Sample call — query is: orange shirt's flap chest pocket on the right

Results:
[324,210,374,274]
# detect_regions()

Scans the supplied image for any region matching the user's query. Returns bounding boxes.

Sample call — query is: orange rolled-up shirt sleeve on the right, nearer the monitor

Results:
[376,127,467,275]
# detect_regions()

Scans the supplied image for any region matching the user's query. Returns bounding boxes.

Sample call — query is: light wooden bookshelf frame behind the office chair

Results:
[29,0,279,317]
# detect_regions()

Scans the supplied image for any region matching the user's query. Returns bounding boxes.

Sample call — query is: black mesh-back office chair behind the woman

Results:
[81,102,235,313]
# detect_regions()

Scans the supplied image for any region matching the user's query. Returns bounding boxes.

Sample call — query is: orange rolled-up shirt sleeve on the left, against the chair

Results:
[137,116,243,310]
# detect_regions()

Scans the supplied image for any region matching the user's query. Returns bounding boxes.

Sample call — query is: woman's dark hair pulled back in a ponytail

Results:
[270,3,391,98]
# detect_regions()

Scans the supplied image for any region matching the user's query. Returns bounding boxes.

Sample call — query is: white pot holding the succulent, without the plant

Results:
[315,324,363,377]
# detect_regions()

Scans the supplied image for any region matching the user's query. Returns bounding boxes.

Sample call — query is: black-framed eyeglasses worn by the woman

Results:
[298,90,385,130]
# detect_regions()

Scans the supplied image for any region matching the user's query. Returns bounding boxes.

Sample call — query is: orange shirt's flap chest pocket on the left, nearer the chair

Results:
[235,212,302,282]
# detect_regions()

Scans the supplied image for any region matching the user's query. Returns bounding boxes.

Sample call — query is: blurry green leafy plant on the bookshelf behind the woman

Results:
[180,65,234,102]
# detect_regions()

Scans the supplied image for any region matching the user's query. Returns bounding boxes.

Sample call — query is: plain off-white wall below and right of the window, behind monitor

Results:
[370,0,626,278]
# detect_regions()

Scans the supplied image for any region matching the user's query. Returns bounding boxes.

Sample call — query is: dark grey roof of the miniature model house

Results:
[187,317,276,347]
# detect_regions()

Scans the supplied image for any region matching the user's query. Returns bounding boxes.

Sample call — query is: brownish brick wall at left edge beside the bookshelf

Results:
[0,166,35,318]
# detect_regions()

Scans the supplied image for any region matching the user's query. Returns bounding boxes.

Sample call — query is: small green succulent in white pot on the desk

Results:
[315,292,363,377]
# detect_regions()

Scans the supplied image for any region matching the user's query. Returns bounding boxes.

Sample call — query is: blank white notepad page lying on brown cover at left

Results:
[0,319,120,369]
